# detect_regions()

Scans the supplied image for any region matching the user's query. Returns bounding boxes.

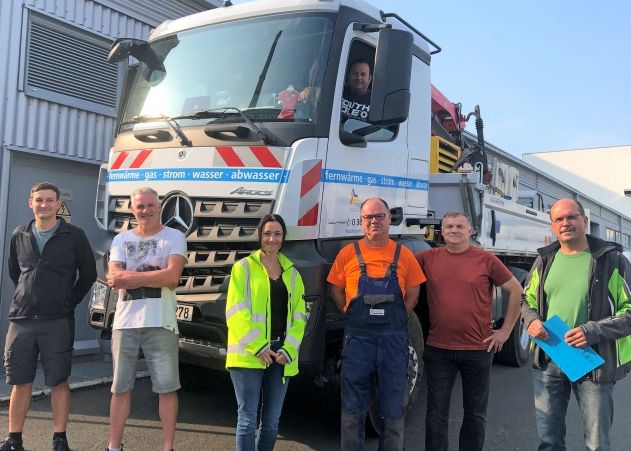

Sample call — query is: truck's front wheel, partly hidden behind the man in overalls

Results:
[368,314,425,432]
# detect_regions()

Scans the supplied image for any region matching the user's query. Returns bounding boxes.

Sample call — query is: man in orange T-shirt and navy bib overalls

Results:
[327,198,425,451]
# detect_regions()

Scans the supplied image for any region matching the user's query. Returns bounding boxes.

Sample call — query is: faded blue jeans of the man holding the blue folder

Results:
[532,362,613,451]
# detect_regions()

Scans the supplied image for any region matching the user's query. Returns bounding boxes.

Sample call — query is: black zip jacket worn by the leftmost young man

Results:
[9,218,96,320]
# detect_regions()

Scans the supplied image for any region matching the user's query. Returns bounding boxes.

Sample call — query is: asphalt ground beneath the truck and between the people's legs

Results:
[0,355,631,451]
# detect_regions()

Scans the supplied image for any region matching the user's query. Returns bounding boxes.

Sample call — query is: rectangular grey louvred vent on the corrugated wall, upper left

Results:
[24,12,120,116]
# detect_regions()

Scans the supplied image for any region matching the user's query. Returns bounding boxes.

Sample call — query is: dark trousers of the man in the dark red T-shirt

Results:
[423,346,493,451]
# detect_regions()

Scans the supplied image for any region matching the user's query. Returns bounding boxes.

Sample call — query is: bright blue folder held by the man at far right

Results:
[533,315,605,382]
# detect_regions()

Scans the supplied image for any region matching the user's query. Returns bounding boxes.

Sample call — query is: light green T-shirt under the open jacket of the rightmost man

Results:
[543,249,591,328]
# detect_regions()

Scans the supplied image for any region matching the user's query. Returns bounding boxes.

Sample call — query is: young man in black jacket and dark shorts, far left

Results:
[0,183,96,451]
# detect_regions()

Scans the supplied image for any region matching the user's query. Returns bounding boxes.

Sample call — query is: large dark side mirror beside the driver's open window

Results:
[368,28,414,126]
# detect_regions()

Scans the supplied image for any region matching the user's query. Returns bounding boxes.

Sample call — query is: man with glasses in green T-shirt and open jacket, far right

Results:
[522,199,631,451]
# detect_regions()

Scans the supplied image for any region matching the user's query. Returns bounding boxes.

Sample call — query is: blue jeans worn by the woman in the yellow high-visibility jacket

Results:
[230,363,288,451]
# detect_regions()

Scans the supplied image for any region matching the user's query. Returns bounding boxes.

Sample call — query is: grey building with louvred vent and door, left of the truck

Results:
[0,0,221,353]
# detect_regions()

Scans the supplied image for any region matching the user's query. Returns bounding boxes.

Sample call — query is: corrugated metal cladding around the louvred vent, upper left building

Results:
[0,0,214,163]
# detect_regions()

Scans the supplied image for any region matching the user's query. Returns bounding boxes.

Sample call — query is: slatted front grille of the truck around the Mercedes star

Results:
[108,197,272,294]
